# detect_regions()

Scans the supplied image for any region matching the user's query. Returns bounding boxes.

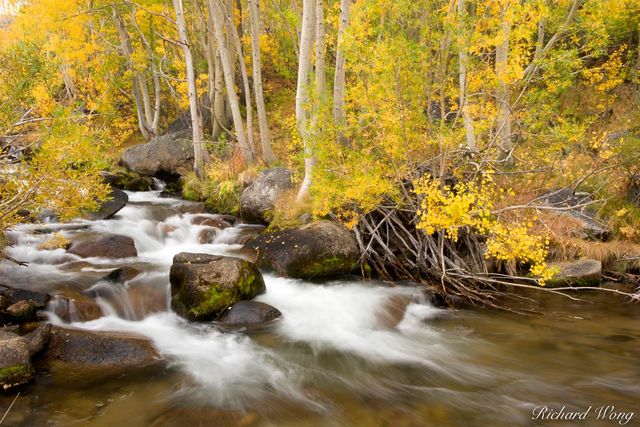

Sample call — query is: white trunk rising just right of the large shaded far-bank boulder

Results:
[173,0,209,178]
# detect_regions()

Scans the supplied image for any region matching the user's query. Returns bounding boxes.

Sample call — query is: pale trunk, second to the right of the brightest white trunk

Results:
[333,0,353,145]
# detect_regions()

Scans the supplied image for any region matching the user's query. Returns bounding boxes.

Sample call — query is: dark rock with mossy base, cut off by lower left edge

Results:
[0,330,34,390]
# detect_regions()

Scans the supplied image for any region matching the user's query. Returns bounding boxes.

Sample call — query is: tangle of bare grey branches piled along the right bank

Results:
[353,186,640,312]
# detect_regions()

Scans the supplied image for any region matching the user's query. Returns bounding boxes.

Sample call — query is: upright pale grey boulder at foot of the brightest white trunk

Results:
[240,168,293,223]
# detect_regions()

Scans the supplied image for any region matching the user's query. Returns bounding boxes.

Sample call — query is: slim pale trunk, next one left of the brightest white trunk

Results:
[249,0,275,165]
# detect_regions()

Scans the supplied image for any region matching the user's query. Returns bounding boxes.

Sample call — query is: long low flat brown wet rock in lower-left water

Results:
[44,327,162,373]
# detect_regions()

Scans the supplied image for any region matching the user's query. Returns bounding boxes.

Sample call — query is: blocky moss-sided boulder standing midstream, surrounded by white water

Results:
[169,253,266,321]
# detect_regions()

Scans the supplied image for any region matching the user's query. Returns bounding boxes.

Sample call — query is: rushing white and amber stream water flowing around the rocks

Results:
[0,192,640,426]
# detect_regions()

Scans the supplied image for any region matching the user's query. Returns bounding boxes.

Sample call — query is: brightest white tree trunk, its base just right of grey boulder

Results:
[296,0,315,201]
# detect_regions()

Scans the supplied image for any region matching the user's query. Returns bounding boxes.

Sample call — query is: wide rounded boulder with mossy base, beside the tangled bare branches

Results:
[247,221,360,279]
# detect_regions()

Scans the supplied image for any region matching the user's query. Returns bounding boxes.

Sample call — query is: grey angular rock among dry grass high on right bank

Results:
[539,188,611,241]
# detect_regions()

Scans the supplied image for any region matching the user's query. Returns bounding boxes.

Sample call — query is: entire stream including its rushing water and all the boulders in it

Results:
[0,191,640,426]
